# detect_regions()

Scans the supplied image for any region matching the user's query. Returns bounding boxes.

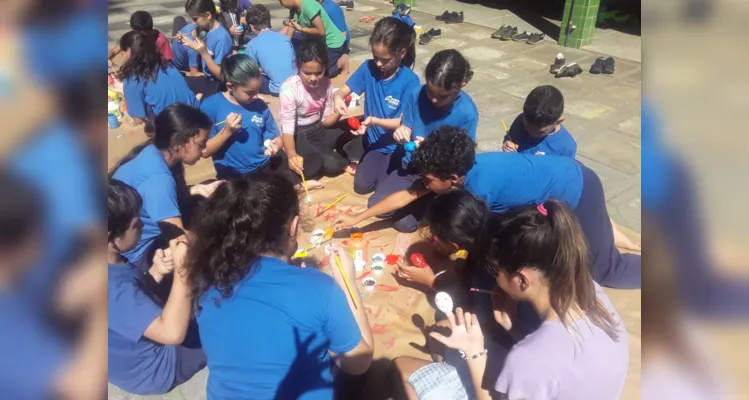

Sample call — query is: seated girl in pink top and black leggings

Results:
[280,37,363,179]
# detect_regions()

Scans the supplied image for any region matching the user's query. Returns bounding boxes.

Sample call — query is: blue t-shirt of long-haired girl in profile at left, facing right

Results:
[113,145,181,265]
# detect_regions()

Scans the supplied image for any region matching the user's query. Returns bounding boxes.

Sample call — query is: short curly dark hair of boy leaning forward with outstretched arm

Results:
[411,125,476,180]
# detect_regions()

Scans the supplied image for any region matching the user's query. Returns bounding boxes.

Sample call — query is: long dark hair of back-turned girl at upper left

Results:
[118,31,169,82]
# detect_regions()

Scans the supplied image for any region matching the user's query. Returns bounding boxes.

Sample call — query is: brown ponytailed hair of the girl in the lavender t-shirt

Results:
[477,200,619,341]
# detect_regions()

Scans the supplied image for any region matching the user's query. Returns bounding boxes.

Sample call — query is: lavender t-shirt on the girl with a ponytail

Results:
[494,284,629,400]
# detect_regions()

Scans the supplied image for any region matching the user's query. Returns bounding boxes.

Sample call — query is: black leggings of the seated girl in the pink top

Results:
[294,122,364,179]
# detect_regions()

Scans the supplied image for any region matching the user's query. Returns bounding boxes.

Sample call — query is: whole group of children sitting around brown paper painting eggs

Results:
[108,0,640,399]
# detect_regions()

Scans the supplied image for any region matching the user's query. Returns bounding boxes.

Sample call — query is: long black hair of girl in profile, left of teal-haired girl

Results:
[109,103,213,179]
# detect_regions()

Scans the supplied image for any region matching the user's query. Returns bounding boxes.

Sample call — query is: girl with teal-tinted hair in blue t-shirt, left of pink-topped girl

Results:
[200,54,288,179]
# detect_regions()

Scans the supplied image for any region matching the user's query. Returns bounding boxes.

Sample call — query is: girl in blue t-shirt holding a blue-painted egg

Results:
[368,50,479,232]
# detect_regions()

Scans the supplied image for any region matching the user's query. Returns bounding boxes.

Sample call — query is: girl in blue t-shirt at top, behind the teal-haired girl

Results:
[172,0,234,97]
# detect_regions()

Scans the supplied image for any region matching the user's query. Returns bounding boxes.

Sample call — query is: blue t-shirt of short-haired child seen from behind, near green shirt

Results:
[247,30,296,93]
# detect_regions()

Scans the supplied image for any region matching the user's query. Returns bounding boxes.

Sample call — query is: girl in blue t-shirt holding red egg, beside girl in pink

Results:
[333,17,419,194]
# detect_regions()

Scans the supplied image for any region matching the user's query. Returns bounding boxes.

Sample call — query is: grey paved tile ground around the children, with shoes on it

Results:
[109,0,641,399]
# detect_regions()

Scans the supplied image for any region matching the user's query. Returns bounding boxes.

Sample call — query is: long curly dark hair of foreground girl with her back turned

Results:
[186,173,299,311]
